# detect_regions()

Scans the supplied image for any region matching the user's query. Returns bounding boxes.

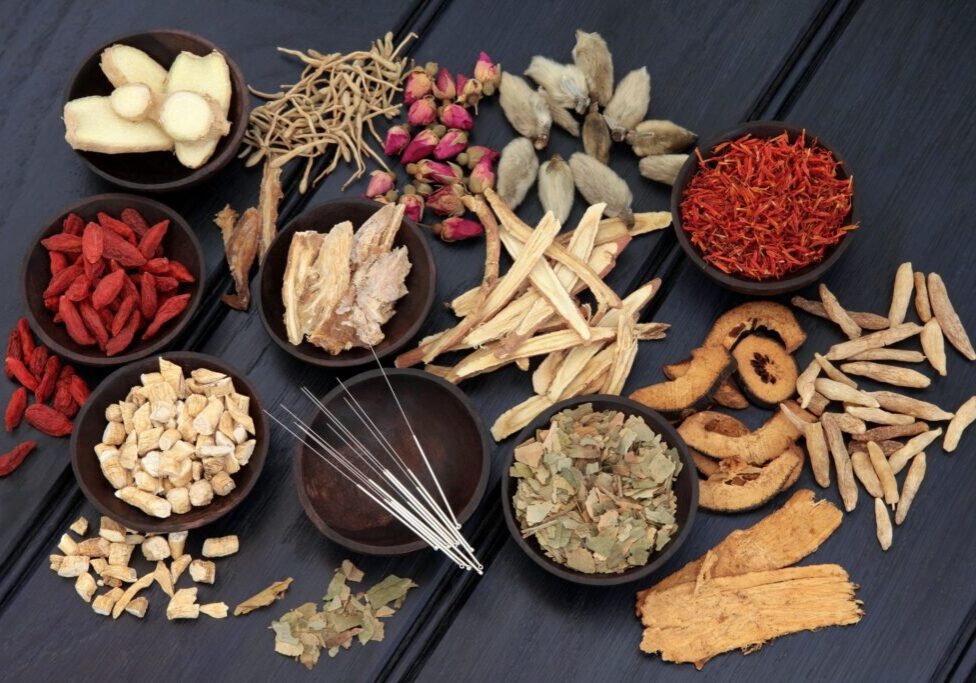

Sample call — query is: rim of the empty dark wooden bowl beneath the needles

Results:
[293,368,491,555]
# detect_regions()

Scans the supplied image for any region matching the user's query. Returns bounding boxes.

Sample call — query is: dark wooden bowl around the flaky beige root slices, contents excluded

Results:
[257,199,437,368]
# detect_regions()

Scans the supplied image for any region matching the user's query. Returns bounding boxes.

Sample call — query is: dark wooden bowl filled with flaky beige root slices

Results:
[258,199,436,368]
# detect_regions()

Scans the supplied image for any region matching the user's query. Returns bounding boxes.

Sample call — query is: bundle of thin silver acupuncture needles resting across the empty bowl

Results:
[268,351,484,574]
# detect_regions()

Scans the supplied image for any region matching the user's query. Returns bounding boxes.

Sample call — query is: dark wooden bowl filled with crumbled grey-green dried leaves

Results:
[501,394,698,586]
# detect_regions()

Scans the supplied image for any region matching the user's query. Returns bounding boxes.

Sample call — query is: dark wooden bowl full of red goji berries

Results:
[22,194,203,367]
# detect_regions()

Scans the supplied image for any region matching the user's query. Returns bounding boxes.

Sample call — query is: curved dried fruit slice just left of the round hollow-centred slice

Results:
[630,346,735,418]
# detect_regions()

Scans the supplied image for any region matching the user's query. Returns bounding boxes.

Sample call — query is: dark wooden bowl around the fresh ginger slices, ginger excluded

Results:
[64,29,250,192]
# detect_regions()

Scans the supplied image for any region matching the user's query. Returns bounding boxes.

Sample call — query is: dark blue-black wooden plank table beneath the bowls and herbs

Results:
[0,0,976,681]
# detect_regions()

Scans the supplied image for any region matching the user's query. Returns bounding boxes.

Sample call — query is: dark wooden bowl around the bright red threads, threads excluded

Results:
[671,121,858,296]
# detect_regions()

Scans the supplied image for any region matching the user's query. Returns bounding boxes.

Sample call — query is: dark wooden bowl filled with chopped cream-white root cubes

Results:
[71,351,269,533]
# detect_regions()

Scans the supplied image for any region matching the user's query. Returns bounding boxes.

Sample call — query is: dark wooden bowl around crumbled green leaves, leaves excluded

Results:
[501,394,698,586]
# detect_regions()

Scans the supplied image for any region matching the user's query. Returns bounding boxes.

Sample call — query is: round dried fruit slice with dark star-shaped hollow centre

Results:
[732,334,800,408]
